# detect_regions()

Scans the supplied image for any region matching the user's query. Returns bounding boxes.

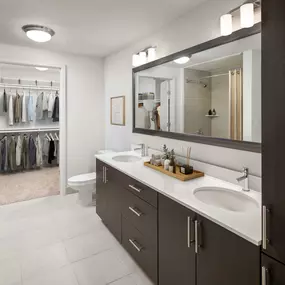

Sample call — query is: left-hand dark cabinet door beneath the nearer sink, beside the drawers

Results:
[158,195,195,285]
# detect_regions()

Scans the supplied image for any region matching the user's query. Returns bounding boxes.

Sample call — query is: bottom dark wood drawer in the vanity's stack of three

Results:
[122,218,157,284]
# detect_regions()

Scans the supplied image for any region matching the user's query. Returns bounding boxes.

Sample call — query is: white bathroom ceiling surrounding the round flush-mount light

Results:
[0,0,206,57]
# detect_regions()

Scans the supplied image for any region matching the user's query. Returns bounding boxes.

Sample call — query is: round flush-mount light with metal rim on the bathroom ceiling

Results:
[22,25,55,43]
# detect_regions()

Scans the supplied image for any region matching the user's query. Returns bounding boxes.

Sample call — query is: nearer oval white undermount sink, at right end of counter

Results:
[194,187,259,212]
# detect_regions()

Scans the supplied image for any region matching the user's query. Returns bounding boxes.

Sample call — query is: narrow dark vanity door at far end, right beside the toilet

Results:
[96,159,107,221]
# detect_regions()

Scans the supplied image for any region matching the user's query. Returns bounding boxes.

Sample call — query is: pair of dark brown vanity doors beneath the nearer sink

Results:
[158,195,260,285]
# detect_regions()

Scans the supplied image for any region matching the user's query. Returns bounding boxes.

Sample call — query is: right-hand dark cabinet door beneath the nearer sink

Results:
[195,216,260,285]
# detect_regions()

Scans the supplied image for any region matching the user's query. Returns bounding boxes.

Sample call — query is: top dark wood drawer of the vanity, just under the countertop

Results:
[123,176,157,208]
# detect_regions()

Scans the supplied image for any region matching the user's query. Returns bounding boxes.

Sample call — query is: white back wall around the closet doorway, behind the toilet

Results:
[0,44,105,177]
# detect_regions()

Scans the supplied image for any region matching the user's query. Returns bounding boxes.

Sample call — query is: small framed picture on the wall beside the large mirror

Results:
[110,96,126,126]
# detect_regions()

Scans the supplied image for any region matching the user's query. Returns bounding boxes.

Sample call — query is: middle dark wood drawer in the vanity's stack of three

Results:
[122,186,157,237]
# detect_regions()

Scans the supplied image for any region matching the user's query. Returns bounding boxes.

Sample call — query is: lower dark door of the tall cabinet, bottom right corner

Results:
[261,254,285,285]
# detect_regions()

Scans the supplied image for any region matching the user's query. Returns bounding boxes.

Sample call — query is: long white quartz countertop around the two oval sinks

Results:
[95,151,261,245]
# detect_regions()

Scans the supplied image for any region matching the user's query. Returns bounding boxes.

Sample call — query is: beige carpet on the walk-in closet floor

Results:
[0,167,60,205]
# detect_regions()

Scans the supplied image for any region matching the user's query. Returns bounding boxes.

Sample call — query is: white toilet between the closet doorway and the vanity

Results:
[68,150,112,206]
